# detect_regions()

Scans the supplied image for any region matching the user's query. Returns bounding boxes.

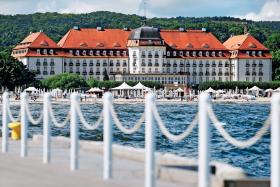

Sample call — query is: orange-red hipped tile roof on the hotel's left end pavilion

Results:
[14,32,59,49]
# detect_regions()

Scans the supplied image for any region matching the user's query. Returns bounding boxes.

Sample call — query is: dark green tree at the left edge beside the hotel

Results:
[0,54,36,90]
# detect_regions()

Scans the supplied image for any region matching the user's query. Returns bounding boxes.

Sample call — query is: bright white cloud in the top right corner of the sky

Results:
[237,0,280,21]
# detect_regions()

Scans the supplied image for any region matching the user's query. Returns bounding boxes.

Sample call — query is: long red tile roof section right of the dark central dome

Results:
[160,30,227,50]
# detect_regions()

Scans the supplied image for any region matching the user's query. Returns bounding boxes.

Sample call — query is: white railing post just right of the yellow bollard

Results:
[20,92,28,158]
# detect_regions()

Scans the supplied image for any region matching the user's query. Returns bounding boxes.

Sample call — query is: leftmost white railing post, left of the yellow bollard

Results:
[2,92,9,153]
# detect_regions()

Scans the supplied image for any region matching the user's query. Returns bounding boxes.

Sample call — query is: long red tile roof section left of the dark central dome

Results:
[58,29,130,49]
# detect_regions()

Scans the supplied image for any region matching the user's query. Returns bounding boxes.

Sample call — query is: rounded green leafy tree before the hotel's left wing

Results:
[42,73,88,89]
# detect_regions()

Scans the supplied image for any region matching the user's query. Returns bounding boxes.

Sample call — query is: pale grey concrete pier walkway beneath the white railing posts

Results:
[0,141,192,187]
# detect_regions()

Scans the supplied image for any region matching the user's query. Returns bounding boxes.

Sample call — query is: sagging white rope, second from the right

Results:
[152,105,198,142]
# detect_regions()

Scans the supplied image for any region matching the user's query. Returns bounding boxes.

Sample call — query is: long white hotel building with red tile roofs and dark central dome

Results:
[12,26,272,84]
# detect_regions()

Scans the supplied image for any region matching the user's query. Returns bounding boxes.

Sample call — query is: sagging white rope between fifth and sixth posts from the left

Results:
[110,105,145,134]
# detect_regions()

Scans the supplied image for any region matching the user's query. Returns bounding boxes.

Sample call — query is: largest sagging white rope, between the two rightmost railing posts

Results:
[207,106,271,149]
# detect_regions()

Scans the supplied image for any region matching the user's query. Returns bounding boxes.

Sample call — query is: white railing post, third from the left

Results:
[43,93,51,164]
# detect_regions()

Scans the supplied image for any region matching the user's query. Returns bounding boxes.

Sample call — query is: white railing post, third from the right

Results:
[145,93,156,187]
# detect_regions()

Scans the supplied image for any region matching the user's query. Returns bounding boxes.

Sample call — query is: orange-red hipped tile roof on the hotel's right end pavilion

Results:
[224,34,268,50]
